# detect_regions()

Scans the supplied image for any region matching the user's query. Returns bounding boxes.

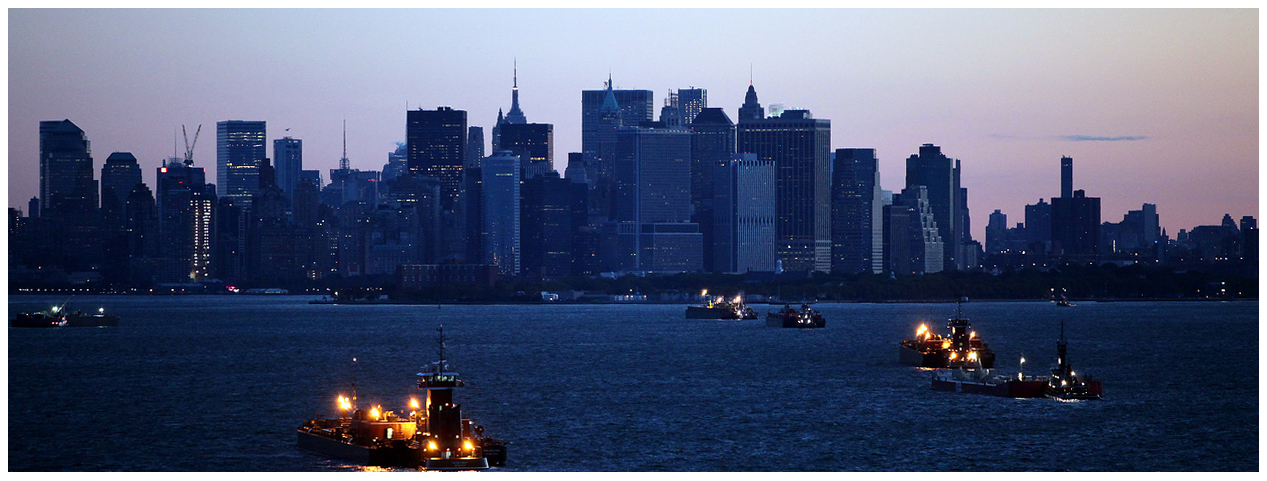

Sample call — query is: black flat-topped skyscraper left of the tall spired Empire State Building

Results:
[405,106,466,211]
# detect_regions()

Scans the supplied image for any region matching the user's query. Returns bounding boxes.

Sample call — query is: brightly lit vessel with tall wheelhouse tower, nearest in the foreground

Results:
[298,327,507,471]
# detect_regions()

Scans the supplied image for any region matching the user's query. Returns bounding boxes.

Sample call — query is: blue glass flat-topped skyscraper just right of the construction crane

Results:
[215,120,267,208]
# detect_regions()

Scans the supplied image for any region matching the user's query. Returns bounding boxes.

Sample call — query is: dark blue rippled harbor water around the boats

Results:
[9,296,1259,471]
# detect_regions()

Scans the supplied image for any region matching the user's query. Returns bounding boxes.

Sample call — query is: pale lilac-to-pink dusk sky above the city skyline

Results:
[8,9,1259,243]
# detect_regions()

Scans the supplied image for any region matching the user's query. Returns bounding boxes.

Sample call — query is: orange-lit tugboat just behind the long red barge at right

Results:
[898,299,995,368]
